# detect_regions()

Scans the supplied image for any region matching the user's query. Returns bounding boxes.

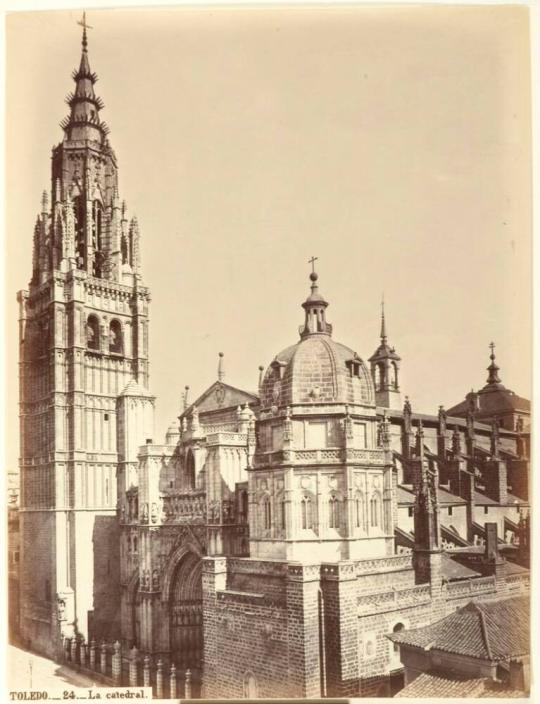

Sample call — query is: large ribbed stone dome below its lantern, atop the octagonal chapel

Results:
[261,334,374,408]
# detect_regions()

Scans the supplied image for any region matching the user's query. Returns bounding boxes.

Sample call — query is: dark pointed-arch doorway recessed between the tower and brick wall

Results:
[169,552,203,683]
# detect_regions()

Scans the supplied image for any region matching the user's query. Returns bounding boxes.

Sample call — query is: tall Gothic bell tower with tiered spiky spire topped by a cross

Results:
[17,15,150,654]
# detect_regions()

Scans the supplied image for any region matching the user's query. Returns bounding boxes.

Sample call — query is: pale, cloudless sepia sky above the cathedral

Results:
[4,6,531,467]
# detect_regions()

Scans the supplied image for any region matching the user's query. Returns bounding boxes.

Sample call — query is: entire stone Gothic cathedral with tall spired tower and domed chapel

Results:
[18,16,530,698]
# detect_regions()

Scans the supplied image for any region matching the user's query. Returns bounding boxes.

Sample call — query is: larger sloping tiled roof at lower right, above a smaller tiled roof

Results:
[388,596,530,661]
